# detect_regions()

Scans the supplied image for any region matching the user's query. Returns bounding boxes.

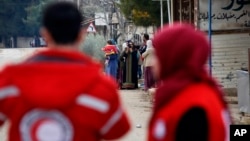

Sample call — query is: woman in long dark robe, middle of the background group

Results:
[120,41,138,89]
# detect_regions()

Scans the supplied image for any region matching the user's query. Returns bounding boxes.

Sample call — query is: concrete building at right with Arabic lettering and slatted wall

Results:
[174,0,250,88]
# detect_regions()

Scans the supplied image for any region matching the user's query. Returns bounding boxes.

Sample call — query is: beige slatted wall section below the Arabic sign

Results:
[212,33,250,88]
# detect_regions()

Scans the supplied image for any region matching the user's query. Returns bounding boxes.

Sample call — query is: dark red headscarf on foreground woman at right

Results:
[153,24,226,112]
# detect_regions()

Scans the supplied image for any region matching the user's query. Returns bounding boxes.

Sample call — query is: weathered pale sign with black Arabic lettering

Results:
[198,0,250,30]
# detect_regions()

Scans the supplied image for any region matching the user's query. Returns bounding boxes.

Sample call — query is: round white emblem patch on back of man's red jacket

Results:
[20,110,73,141]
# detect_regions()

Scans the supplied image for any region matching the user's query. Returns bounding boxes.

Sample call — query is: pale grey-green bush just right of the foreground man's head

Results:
[81,34,106,61]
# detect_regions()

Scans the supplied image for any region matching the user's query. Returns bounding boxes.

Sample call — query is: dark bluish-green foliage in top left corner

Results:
[0,0,51,37]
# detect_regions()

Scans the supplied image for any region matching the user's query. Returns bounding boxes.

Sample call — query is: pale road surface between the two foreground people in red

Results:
[0,90,152,141]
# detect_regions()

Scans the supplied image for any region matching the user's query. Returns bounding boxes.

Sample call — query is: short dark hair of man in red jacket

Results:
[42,2,83,44]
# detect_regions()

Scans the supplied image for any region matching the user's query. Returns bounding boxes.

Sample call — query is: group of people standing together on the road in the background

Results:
[102,34,155,91]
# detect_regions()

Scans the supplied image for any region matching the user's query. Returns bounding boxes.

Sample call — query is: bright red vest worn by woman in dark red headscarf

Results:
[148,84,231,141]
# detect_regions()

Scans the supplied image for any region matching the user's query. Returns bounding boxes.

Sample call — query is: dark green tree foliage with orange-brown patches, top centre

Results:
[119,0,168,27]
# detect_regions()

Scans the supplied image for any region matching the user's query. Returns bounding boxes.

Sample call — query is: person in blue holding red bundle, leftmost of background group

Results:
[102,40,118,80]
